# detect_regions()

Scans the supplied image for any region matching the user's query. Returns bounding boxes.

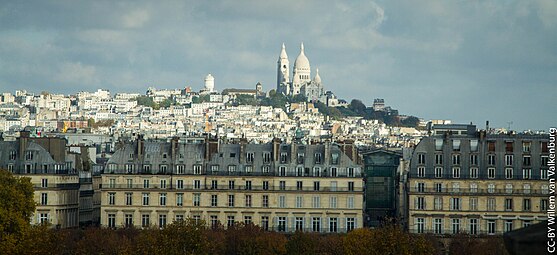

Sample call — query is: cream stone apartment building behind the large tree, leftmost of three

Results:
[0,131,92,228]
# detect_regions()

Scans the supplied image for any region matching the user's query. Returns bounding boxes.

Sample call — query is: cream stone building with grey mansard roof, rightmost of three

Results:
[407,125,549,235]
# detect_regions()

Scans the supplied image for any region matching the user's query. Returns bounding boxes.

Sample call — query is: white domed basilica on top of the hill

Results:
[277,43,325,101]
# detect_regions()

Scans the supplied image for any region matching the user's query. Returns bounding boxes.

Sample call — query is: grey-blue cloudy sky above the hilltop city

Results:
[0,0,557,130]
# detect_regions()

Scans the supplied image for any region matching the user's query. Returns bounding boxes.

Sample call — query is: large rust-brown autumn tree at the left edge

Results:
[0,169,35,254]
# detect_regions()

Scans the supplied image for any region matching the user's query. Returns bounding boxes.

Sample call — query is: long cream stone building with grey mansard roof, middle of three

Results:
[101,138,363,232]
